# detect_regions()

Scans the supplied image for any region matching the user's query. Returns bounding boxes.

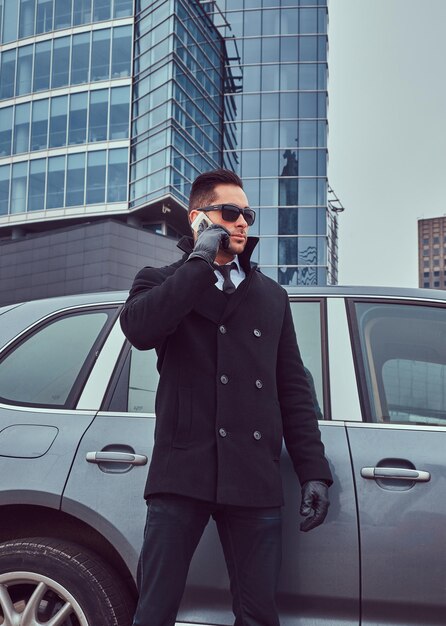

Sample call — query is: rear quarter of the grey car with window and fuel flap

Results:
[0,302,116,508]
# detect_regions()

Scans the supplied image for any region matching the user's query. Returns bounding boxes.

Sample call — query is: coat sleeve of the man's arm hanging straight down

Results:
[277,297,333,485]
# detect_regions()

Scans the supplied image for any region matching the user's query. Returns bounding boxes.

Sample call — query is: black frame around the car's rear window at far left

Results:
[0,303,121,411]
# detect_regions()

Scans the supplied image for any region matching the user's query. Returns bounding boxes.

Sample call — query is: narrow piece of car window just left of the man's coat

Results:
[127,346,159,413]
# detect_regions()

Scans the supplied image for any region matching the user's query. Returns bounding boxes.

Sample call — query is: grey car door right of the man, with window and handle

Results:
[348,299,446,626]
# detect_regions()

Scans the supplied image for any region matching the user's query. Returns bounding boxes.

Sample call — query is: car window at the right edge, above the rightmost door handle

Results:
[355,302,446,426]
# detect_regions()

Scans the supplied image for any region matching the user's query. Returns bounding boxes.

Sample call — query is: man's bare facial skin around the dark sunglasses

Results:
[189,184,249,264]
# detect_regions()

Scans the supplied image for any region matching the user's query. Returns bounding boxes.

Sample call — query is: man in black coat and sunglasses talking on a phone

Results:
[121,170,332,626]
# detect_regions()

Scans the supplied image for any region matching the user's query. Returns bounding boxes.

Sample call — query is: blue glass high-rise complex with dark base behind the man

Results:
[0,0,337,303]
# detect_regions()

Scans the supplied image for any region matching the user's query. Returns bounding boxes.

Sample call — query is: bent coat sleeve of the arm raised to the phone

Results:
[120,259,217,350]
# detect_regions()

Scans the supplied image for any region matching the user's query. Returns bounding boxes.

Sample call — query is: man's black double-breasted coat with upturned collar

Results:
[121,238,331,507]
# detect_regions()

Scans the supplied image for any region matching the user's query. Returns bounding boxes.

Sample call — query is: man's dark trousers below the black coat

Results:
[133,494,282,626]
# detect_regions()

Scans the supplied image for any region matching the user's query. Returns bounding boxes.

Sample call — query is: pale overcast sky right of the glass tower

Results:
[328,0,446,287]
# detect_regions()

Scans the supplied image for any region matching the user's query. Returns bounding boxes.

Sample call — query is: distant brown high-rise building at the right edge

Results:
[418,215,446,289]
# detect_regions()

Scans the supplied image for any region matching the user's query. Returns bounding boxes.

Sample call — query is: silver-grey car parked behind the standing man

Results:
[0,287,446,626]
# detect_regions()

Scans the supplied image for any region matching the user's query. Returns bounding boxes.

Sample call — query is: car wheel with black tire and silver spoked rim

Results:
[0,538,133,626]
